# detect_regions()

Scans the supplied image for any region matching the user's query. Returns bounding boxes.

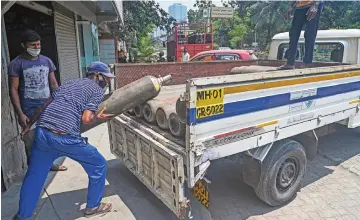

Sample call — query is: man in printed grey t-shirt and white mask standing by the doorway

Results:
[8,30,67,171]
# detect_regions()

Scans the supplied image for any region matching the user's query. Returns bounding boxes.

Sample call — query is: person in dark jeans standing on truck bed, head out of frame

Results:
[279,1,324,70]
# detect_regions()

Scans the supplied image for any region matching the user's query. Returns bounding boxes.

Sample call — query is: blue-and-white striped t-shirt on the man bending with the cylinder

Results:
[36,78,104,136]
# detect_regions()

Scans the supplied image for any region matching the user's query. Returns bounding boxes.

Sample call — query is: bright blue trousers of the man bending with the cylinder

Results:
[18,127,106,220]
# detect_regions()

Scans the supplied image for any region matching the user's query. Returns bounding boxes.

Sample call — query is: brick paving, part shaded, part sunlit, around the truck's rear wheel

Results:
[205,130,360,220]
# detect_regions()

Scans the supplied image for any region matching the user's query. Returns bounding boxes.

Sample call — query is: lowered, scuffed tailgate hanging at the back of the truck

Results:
[108,117,186,219]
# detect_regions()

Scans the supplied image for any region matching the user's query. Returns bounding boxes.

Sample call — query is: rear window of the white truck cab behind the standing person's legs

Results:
[277,42,344,63]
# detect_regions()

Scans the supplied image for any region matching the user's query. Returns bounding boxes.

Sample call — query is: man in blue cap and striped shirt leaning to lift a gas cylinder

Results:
[14,62,115,220]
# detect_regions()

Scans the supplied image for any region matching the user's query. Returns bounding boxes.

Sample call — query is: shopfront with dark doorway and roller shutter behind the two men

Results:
[1,1,123,191]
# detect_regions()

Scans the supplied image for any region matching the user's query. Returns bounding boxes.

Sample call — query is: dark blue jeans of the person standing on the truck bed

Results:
[287,8,322,65]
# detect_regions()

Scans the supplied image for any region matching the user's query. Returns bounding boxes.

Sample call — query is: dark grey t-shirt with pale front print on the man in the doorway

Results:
[8,55,56,117]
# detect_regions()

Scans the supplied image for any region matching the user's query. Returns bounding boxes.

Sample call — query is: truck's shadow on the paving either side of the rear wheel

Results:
[208,129,360,220]
